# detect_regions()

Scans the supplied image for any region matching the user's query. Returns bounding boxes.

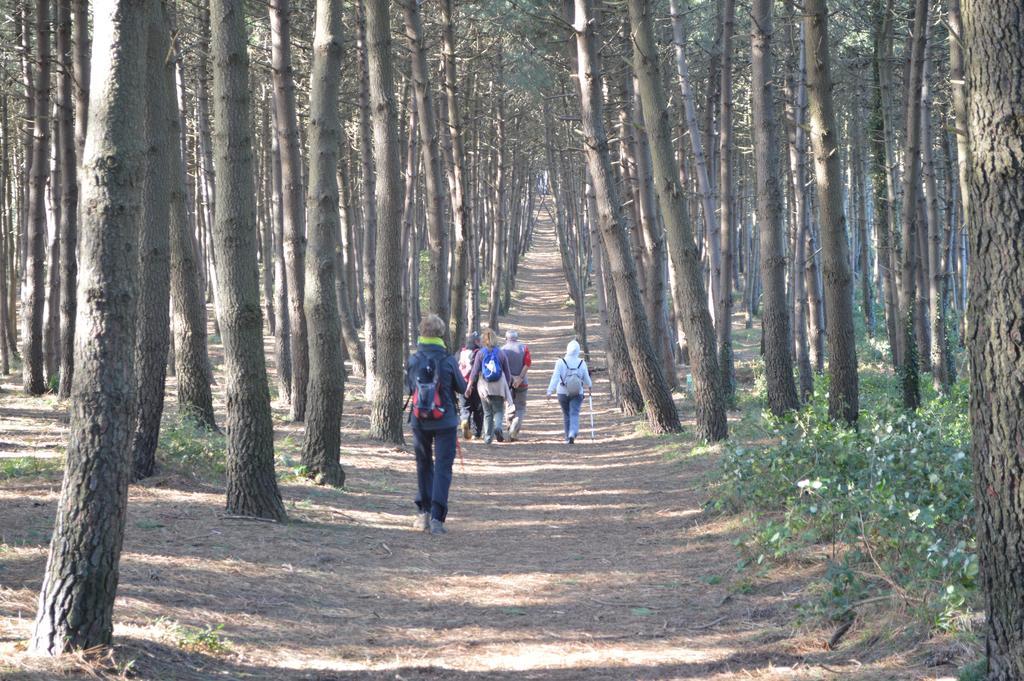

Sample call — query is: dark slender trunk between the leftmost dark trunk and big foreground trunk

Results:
[57,0,81,397]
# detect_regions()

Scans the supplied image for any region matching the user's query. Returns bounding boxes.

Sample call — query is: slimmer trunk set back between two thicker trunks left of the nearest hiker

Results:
[269,0,309,421]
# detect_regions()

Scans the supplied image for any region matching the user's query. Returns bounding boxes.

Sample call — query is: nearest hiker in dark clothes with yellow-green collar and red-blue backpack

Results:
[406,314,466,535]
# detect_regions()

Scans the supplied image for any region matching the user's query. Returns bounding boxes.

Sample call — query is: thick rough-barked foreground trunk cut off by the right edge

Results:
[963,0,1024,681]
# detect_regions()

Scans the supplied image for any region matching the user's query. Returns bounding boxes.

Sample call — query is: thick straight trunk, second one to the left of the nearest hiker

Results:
[302,0,345,485]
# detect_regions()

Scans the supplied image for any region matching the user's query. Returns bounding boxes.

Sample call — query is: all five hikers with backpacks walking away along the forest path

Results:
[406,314,593,535]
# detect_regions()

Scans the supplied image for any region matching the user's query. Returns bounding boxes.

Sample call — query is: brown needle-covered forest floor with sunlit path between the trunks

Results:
[0,212,955,681]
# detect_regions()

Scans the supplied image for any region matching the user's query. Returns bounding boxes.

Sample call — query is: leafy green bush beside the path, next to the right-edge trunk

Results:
[713,380,978,630]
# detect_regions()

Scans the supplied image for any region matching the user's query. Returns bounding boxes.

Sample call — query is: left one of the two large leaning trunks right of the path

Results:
[573,0,682,432]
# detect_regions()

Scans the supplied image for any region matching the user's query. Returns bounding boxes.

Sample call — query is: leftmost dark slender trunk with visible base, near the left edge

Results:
[22,0,50,395]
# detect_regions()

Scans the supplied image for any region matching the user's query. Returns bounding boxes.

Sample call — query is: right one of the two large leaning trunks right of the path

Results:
[629,0,728,442]
